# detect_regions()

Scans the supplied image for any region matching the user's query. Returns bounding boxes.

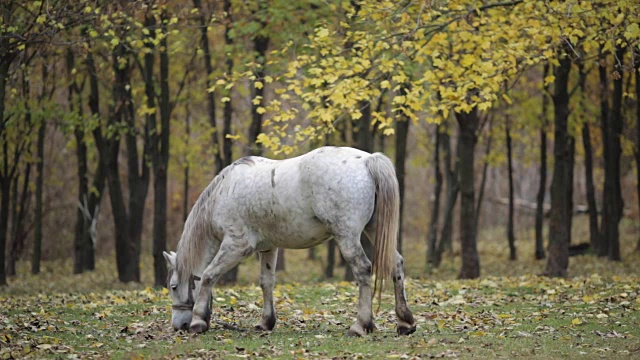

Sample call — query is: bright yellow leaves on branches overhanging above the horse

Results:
[216,0,640,152]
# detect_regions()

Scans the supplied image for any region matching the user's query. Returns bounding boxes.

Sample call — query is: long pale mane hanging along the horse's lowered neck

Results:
[176,166,233,282]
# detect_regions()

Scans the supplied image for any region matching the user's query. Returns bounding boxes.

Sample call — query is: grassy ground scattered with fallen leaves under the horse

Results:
[0,219,640,359]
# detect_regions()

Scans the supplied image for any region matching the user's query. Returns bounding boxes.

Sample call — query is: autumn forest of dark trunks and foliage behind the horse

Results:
[0,0,640,286]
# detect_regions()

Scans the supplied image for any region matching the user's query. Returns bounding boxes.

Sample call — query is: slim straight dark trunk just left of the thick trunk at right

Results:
[535,64,549,260]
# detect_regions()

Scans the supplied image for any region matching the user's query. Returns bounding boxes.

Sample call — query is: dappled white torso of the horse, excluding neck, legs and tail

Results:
[216,147,375,249]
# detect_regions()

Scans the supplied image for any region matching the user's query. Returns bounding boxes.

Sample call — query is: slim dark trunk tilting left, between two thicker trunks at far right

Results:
[578,63,600,250]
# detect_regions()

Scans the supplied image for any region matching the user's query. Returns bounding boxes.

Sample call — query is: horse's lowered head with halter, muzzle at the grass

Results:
[162,251,212,330]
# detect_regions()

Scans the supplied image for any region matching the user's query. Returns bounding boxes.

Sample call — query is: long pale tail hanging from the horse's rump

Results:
[365,153,400,306]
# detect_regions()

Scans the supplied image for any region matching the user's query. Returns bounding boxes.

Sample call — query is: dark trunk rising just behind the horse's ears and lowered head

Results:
[154,11,171,286]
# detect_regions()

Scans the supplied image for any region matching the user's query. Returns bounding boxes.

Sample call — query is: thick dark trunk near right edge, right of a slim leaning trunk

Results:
[600,48,625,261]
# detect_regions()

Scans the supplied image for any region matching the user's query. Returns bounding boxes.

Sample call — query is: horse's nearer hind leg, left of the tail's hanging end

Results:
[336,236,375,336]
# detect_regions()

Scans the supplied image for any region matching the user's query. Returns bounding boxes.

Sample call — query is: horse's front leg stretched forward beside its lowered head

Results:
[190,237,253,333]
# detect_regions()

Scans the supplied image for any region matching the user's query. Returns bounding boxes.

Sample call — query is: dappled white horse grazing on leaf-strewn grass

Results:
[164,147,416,336]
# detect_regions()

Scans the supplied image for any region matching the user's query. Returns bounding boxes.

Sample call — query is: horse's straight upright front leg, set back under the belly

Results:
[256,249,278,330]
